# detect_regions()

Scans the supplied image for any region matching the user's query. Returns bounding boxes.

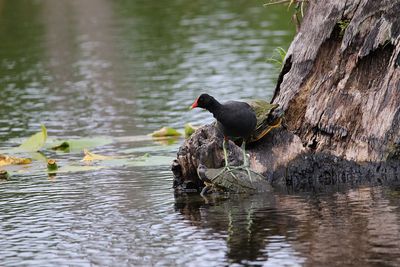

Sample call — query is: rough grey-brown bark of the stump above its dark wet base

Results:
[273,0,400,162]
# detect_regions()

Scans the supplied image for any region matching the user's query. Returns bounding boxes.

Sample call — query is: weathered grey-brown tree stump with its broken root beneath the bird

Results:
[172,0,400,193]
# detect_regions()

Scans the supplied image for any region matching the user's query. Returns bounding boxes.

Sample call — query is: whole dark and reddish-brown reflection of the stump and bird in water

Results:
[175,188,400,266]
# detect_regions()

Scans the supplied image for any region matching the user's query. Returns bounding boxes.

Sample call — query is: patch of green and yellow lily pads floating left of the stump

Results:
[0,123,173,176]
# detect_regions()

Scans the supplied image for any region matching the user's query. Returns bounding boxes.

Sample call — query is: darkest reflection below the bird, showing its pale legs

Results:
[175,194,294,263]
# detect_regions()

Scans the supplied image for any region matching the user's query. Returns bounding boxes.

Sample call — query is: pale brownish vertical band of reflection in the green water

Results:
[42,0,122,135]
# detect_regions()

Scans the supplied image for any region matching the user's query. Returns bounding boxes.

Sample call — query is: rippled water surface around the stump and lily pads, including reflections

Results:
[0,0,400,266]
